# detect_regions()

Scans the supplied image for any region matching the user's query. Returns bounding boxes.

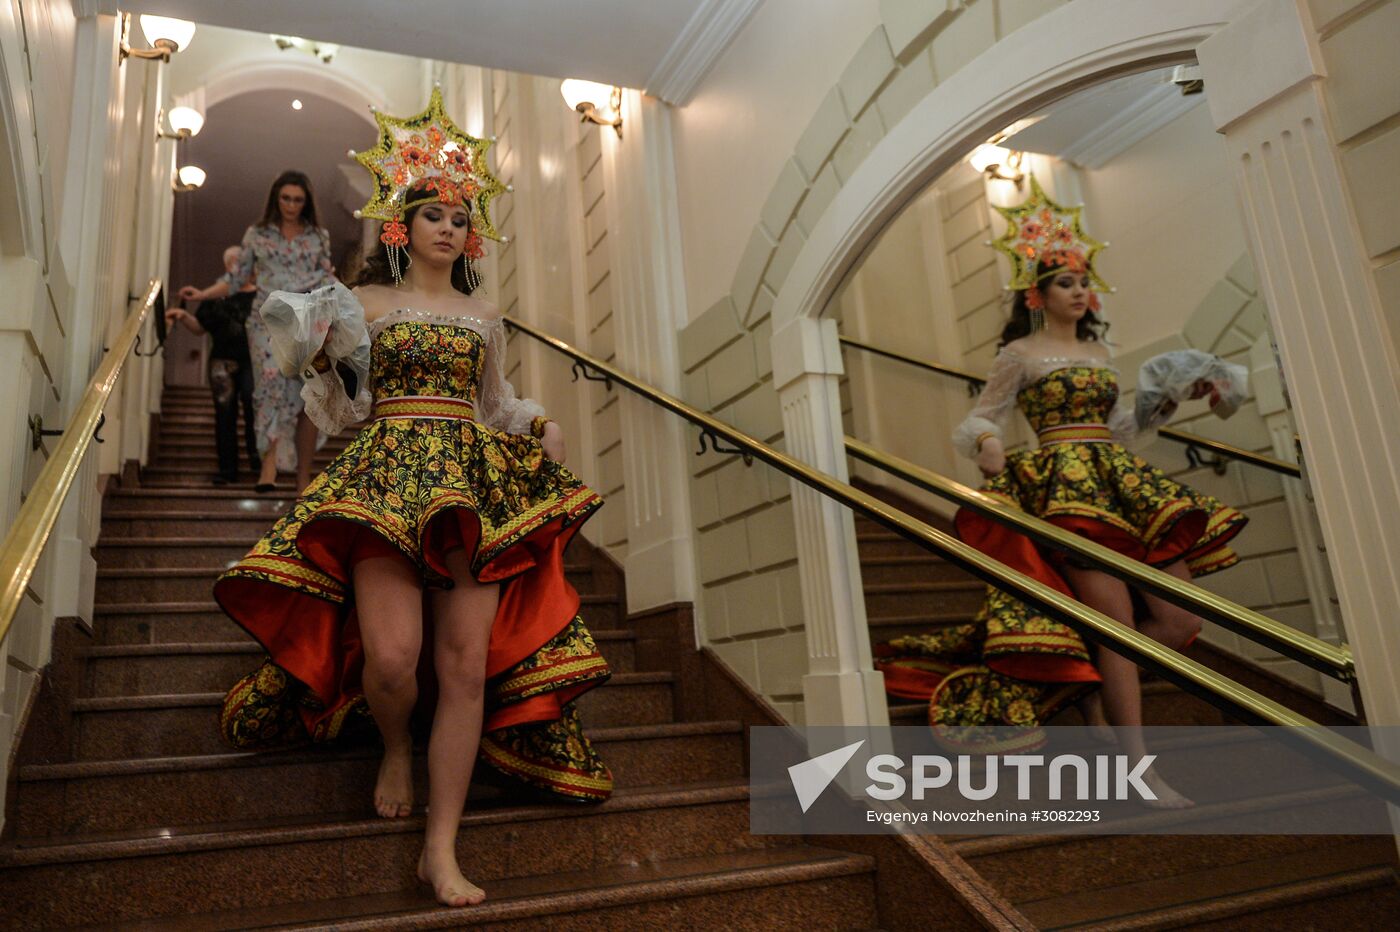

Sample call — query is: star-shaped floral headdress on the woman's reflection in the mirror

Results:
[991,175,1113,319]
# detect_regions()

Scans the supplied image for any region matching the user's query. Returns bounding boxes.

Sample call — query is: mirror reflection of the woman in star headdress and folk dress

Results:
[878,178,1247,807]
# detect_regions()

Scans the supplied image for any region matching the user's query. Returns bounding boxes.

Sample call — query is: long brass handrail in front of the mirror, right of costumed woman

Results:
[505,318,1400,805]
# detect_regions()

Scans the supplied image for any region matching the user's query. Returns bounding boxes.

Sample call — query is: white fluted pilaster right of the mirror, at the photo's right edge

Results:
[1198,0,1400,725]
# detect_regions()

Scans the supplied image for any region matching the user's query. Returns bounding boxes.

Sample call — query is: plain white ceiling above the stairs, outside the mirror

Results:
[120,0,762,104]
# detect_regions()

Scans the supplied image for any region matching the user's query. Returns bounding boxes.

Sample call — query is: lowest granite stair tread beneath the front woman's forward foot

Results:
[95,845,875,932]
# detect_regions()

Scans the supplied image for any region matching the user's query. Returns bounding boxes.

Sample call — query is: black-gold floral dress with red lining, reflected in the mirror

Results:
[876,348,1247,746]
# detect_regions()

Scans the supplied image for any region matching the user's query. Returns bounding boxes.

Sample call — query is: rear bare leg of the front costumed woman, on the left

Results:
[354,556,423,819]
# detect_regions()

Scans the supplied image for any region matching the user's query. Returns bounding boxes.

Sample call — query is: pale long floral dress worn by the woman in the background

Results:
[227,224,335,473]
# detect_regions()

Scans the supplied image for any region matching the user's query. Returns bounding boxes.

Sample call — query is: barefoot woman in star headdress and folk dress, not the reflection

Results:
[214,91,612,905]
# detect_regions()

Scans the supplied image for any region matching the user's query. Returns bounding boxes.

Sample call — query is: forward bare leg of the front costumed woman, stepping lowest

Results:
[419,549,500,907]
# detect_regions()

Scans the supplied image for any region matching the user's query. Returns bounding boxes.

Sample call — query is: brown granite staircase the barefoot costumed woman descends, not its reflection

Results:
[0,388,876,929]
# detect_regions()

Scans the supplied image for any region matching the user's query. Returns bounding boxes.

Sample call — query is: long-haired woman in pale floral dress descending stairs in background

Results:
[181,171,335,491]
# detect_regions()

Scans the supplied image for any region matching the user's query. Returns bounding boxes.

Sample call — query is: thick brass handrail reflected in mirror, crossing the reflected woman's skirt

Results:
[846,437,1357,683]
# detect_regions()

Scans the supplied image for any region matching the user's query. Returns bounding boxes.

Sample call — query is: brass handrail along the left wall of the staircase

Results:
[0,278,161,642]
